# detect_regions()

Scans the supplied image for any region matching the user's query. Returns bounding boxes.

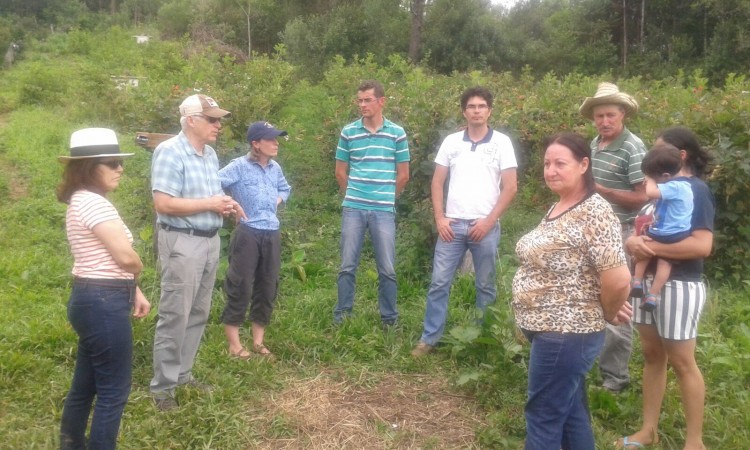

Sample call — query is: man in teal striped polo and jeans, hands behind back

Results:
[333,80,410,327]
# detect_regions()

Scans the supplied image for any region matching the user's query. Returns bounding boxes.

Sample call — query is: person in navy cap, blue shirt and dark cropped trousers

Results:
[219,122,291,359]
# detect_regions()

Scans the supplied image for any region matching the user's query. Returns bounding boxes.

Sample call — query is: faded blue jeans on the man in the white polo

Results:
[419,219,500,345]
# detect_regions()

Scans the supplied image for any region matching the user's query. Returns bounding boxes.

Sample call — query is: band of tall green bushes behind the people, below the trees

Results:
[0,28,750,280]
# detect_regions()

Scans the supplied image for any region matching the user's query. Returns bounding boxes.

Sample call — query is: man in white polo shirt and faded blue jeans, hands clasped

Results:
[412,87,517,357]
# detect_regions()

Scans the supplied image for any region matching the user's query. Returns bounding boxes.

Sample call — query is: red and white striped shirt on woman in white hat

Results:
[65,190,134,280]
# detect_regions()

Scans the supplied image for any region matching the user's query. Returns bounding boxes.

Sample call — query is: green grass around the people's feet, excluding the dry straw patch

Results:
[0,104,750,449]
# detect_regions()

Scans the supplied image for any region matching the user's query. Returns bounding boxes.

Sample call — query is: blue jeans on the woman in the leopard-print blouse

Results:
[523,330,604,450]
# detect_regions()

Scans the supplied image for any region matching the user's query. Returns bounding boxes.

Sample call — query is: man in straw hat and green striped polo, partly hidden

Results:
[579,83,648,392]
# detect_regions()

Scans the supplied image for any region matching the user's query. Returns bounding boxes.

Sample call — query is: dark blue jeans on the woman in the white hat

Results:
[60,279,135,450]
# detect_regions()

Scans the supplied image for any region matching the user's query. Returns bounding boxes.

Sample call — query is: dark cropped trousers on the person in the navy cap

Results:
[221,225,281,326]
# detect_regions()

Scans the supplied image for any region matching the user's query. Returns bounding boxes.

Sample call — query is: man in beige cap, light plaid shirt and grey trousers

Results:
[151,94,244,411]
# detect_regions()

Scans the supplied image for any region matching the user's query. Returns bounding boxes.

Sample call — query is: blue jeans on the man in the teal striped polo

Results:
[333,208,398,323]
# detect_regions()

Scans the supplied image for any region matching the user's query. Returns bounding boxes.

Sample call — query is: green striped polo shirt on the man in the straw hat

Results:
[591,128,647,223]
